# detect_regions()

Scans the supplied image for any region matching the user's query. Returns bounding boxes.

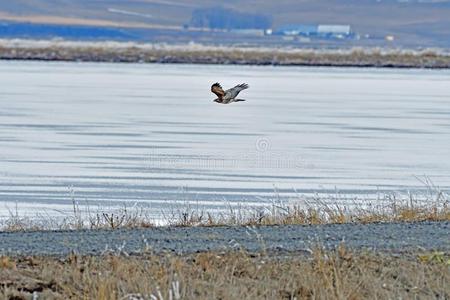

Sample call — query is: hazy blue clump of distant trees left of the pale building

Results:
[190,7,272,30]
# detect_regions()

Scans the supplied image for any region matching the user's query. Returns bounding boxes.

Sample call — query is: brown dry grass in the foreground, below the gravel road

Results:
[0,247,450,300]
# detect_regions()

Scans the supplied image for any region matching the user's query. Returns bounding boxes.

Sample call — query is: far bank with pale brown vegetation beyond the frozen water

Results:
[0,40,450,69]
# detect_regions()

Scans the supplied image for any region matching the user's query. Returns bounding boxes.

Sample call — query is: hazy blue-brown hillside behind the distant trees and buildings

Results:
[0,0,450,47]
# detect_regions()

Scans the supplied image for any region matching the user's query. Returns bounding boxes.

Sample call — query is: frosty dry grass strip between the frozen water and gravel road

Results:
[0,192,450,232]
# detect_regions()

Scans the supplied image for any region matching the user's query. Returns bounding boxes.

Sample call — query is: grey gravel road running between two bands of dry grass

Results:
[0,222,450,256]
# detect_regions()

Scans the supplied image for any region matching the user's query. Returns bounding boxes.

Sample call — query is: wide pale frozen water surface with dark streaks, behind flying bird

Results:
[0,62,450,216]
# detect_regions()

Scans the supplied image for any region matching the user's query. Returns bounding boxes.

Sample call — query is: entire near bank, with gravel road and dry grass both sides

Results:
[0,199,450,299]
